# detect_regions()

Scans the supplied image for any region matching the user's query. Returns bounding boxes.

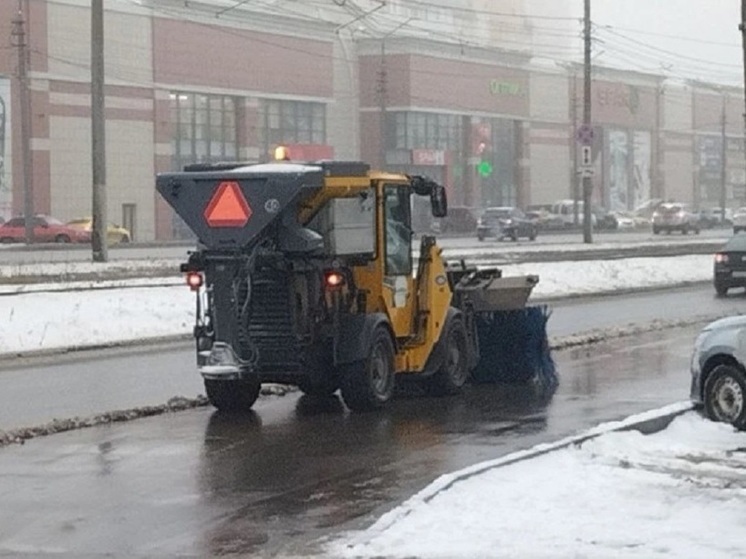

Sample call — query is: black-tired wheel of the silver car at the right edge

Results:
[703,365,746,431]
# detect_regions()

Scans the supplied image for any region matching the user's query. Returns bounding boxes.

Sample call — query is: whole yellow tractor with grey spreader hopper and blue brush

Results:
[156,155,556,411]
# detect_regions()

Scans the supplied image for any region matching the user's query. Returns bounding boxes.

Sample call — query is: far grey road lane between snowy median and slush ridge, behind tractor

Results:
[0,285,746,430]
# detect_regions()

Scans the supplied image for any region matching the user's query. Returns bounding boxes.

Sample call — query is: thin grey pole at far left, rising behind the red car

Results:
[11,0,34,244]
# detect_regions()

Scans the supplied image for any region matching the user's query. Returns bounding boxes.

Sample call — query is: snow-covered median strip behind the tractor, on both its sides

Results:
[0,255,712,355]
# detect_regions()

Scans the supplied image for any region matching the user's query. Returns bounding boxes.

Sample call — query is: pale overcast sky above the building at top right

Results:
[572,0,743,86]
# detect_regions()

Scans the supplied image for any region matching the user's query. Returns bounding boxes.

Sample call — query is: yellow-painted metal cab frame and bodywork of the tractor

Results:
[298,168,452,373]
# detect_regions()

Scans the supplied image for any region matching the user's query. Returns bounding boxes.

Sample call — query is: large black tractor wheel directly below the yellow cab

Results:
[339,326,394,411]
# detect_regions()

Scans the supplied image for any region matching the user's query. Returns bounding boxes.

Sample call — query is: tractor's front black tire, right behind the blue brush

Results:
[427,319,469,396]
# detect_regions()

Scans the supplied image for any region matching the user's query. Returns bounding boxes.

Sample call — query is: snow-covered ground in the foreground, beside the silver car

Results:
[327,405,746,559]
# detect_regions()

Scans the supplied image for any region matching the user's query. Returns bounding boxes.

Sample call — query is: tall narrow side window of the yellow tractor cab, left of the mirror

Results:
[383,184,412,276]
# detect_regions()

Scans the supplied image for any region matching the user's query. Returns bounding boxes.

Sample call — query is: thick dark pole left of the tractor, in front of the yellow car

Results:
[91,0,109,262]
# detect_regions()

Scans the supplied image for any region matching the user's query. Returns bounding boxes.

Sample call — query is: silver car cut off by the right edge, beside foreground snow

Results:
[690,315,746,430]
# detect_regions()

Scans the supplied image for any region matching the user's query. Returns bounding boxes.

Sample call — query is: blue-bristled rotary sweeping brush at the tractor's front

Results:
[472,306,558,390]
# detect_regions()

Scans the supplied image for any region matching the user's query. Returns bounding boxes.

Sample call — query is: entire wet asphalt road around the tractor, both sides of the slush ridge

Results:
[0,286,746,559]
